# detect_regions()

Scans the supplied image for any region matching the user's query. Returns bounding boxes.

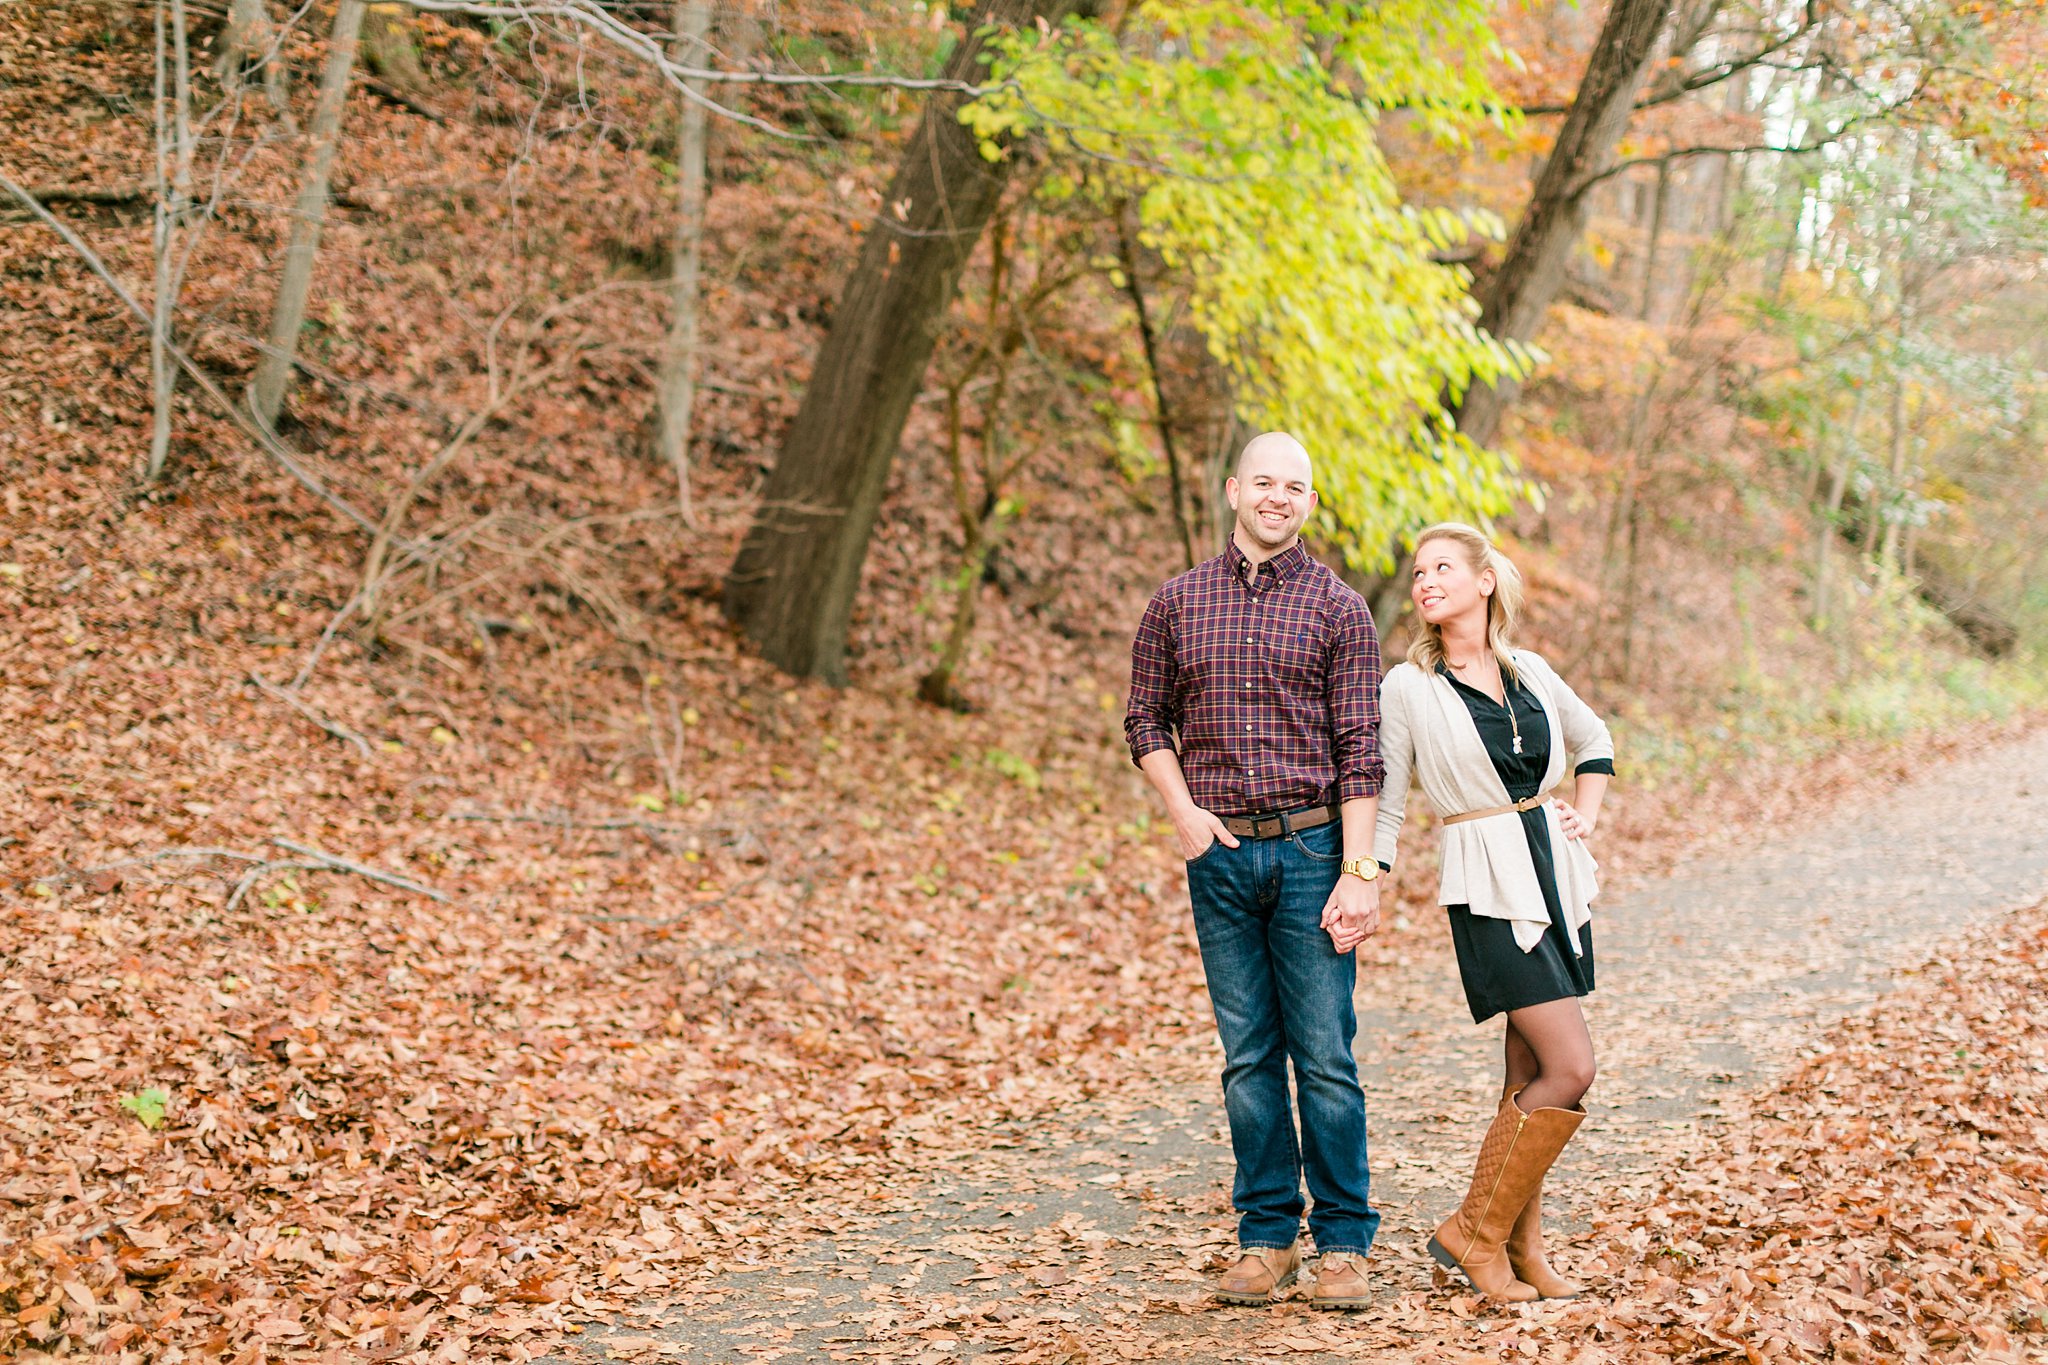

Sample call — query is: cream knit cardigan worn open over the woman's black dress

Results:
[1372,649,1614,956]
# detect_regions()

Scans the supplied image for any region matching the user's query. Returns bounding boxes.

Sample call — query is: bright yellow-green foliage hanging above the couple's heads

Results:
[963,0,1532,569]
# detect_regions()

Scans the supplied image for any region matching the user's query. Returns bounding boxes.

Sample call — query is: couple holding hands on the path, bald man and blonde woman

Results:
[1124,432,1614,1310]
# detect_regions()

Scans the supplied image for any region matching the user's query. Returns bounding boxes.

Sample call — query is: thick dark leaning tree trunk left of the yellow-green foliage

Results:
[725,0,1077,684]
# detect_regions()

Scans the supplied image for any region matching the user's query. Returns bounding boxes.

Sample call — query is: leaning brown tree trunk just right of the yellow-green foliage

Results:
[1458,0,1671,446]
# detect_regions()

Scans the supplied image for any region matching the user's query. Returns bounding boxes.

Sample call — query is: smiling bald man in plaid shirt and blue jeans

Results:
[1124,432,1382,1308]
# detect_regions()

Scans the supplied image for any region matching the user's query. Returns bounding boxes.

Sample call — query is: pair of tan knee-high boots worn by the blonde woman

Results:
[1430,1095,1585,1304]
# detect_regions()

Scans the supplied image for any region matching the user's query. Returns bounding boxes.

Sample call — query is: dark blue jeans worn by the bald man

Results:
[1188,821,1380,1257]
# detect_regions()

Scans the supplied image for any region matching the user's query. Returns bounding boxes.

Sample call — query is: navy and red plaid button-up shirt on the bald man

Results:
[1124,540,1386,814]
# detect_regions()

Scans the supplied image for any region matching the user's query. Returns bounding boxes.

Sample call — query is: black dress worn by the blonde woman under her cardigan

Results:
[1438,667,1614,1023]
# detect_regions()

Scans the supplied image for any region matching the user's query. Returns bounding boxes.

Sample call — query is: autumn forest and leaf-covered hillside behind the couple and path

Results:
[0,0,2048,1359]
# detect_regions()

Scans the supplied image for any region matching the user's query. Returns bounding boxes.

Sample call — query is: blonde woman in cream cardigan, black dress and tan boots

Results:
[1374,522,1614,1302]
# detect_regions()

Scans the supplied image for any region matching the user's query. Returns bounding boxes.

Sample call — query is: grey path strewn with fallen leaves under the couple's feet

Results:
[557,733,2048,1365]
